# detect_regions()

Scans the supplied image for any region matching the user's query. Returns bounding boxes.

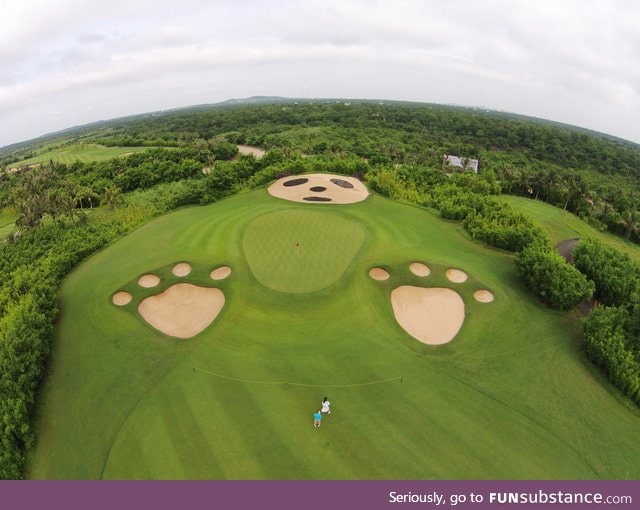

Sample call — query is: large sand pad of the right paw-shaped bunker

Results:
[391,285,464,345]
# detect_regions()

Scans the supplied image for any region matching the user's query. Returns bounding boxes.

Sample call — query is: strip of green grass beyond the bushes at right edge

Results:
[494,195,640,261]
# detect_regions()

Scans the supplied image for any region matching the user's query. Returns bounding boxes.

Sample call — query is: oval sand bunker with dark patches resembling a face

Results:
[268,174,369,204]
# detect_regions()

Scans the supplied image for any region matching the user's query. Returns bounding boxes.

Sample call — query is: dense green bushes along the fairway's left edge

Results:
[0,225,118,479]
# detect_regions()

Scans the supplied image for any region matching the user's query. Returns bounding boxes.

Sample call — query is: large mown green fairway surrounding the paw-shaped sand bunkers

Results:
[27,186,640,479]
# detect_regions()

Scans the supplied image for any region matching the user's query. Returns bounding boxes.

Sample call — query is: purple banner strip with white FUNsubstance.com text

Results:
[0,480,640,510]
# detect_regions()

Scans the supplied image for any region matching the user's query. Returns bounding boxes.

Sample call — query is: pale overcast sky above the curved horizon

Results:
[0,0,640,147]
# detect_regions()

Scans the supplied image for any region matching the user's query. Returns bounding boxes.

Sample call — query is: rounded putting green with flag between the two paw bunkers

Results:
[242,209,365,294]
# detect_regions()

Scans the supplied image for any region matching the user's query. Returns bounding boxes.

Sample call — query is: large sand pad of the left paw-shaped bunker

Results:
[138,283,224,338]
